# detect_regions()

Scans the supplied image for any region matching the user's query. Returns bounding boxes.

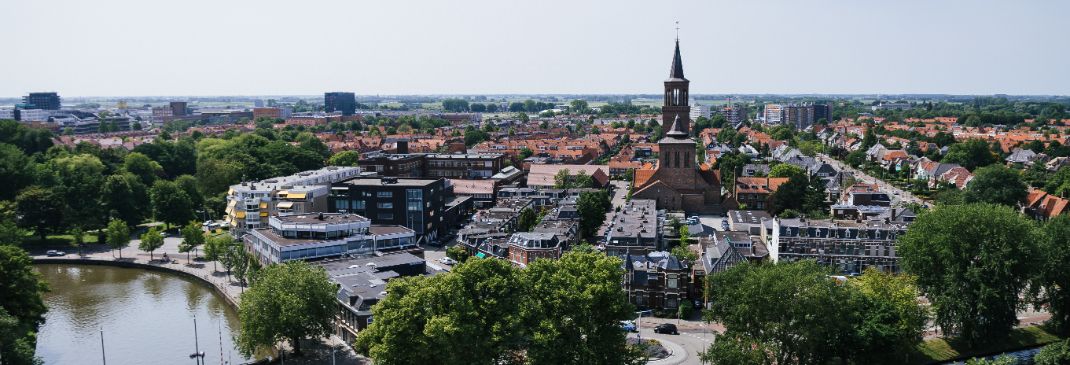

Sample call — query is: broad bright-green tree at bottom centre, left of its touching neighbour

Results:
[355,259,528,365]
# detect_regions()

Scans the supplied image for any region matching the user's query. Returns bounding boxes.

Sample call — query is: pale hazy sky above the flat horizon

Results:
[0,0,1070,96]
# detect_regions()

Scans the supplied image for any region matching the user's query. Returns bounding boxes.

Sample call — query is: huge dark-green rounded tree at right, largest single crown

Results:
[899,204,1041,345]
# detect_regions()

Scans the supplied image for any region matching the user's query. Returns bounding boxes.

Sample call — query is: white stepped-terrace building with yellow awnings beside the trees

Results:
[224,166,361,234]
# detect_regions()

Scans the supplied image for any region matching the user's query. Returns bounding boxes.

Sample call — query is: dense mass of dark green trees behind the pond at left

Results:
[0,121,330,247]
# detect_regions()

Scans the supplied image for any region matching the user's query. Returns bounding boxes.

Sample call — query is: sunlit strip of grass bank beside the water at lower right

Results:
[910,325,1060,365]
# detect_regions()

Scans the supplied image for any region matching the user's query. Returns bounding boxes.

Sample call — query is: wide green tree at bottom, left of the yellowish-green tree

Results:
[706,260,854,365]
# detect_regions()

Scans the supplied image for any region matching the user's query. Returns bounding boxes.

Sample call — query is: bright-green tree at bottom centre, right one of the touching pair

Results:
[520,252,640,364]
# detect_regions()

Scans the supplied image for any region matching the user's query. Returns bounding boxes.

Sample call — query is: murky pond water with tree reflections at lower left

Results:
[35,264,249,365]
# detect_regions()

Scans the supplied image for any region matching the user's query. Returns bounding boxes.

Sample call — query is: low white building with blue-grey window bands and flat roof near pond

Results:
[242,213,416,264]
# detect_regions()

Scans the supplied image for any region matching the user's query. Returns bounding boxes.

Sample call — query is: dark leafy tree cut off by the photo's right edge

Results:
[1030,214,1070,335]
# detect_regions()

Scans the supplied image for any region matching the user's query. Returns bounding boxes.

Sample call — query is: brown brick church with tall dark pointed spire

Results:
[631,40,721,213]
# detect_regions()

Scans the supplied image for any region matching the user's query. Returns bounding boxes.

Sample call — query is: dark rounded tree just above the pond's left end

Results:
[15,186,64,242]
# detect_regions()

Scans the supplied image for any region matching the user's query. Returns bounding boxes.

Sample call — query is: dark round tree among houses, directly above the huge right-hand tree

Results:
[963,165,1028,207]
